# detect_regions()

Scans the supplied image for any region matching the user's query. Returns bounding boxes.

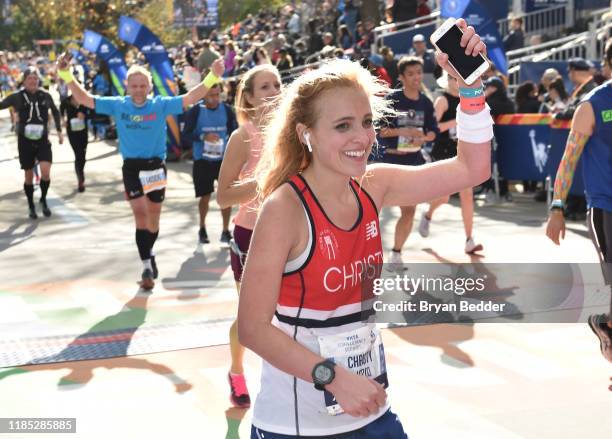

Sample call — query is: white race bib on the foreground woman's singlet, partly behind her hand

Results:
[318,325,389,416]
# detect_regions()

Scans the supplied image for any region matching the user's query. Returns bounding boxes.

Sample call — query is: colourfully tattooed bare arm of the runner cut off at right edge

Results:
[546,102,595,245]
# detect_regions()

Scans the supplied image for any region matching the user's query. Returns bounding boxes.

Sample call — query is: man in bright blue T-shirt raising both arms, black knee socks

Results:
[58,54,224,290]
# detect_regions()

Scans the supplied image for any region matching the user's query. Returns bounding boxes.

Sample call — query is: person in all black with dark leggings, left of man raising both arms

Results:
[60,95,89,192]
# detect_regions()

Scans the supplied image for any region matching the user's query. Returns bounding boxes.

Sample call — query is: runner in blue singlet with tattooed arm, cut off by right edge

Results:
[546,38,612,374]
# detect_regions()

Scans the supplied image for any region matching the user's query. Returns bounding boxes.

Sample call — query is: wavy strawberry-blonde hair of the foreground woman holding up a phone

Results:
[254,59,393,201]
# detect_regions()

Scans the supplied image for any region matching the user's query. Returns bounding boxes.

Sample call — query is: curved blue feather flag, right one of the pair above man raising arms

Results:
[119,16,180,152]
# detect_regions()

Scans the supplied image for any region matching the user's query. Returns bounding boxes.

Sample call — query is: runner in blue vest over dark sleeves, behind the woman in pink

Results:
[184,85,238,244]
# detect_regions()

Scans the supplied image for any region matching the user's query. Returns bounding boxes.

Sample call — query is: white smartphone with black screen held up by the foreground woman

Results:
[430,18,489,85]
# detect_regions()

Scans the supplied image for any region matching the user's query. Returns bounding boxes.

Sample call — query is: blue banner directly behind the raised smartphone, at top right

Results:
[440,0,508,75]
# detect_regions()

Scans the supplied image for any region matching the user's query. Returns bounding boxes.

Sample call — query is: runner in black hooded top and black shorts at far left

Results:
[0,67,64,219]
